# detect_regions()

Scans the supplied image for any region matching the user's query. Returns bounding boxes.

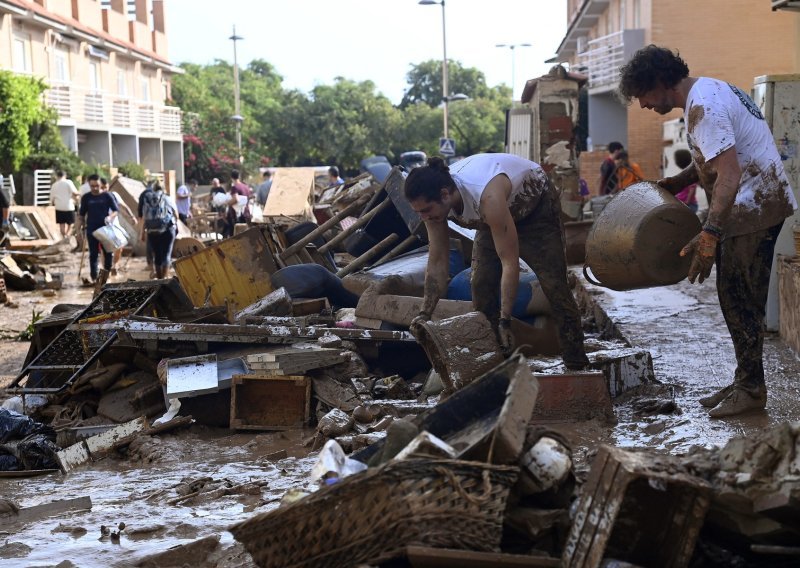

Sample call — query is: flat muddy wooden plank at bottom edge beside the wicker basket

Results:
[406,546,561,568]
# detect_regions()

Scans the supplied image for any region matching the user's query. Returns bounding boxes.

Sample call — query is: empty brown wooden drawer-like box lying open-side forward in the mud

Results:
[230,374,311,430]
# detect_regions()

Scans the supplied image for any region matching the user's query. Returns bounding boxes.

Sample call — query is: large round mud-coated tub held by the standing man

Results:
[583,182,701,290]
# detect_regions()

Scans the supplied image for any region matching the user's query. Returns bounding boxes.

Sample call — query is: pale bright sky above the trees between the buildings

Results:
[166,0,567,103]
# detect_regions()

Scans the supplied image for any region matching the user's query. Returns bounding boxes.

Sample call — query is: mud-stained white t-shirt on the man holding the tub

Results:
[684,77,797,237]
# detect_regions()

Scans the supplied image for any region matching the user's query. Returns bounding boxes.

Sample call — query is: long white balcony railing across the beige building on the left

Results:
[45,85,181,136]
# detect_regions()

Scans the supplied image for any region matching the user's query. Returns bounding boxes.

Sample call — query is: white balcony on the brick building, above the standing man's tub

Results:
[577,29,644,94]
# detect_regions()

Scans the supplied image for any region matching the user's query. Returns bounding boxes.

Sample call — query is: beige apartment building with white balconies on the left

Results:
[0,0,183,180]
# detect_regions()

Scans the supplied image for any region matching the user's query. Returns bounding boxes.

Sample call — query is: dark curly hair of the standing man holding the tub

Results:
[617,44,689,103]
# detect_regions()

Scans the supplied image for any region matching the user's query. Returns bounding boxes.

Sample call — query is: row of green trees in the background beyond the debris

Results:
[172,60,511,174]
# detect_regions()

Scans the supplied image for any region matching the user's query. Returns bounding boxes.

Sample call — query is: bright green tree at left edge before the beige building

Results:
[0,70,52,171]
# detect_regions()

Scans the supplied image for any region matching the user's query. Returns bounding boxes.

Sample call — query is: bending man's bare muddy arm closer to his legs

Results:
[481,176,519,320]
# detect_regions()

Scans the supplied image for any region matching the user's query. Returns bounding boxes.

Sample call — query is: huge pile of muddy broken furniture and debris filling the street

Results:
[6,165,788,567]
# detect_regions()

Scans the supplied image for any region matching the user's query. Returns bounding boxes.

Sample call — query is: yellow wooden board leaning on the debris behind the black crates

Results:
[175,228,277,310]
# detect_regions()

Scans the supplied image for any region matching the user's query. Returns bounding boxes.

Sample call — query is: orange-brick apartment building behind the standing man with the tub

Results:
[555,0,800,191]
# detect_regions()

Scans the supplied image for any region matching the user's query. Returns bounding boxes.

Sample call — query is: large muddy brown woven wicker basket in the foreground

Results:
[230,459,518,568]
